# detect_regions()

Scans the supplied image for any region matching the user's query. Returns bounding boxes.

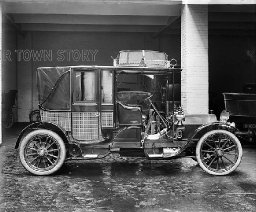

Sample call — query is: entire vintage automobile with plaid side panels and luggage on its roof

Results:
[16,50,242,175]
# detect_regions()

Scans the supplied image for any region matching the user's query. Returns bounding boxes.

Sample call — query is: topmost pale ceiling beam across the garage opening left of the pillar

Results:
[3,0,181,16]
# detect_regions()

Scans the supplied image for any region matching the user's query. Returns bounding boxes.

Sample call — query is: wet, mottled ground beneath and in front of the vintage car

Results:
[0,125,256,212]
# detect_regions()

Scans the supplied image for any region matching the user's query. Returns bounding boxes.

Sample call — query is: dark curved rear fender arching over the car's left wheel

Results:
[15,122,68,149]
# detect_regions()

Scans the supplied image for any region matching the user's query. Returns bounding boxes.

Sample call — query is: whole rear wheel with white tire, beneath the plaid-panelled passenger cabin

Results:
[19,129,66,175]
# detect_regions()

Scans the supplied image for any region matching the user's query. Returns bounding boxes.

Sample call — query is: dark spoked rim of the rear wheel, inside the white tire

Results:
[24,135,61,172]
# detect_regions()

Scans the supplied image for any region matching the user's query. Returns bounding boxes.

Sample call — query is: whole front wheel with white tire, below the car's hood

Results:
[196,130,243,175]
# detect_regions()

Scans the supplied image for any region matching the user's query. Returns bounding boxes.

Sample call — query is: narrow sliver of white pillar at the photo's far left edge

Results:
[0,3,3,144]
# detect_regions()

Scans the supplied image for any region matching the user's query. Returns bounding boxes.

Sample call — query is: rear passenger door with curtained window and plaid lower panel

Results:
[71,69,102,143]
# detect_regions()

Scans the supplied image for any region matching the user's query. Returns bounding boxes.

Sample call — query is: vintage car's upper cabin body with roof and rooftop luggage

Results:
[37,50,180,143]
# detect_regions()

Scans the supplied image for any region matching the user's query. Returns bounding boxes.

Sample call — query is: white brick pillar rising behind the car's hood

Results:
[181,4,209,114]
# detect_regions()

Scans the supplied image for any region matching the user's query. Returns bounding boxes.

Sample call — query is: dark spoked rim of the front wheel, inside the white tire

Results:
[200,131,241,174]
